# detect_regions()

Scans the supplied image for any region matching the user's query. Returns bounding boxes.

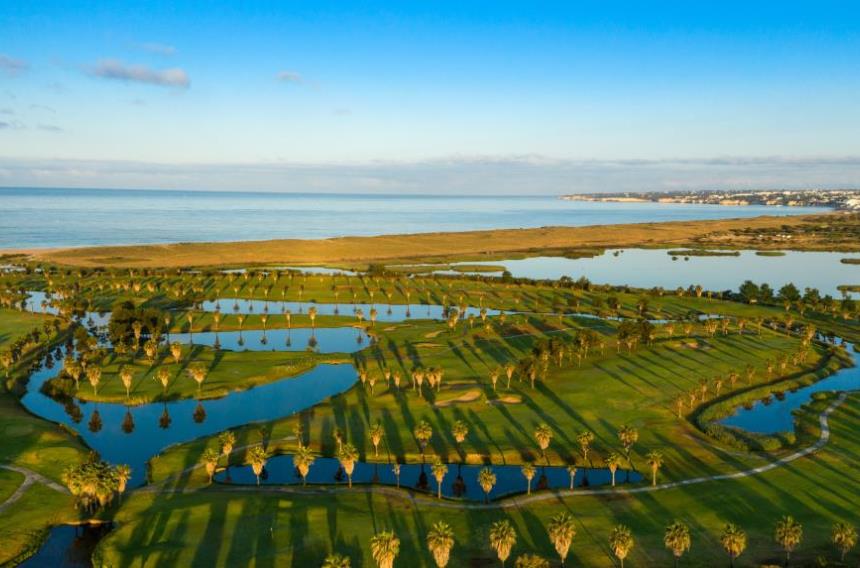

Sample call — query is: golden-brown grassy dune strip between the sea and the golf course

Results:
[20,215,856,268]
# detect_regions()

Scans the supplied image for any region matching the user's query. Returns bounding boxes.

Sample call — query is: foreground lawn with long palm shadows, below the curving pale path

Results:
[97,395,860,568]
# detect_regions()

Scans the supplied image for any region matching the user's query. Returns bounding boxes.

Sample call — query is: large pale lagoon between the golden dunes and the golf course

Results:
[455,249,860,298]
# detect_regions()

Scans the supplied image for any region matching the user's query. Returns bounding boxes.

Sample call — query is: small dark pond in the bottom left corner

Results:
[18,523,111,568]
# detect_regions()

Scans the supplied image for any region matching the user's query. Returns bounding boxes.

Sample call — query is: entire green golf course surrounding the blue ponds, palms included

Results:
[0,271,860,566]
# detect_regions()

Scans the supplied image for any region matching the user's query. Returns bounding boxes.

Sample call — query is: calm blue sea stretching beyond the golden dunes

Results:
[0,188,821,249]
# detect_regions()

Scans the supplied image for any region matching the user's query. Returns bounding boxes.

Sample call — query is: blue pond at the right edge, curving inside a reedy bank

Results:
[720,343,860,434]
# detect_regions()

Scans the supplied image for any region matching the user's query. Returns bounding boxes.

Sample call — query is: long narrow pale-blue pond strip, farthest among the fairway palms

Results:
[201,298,501,323]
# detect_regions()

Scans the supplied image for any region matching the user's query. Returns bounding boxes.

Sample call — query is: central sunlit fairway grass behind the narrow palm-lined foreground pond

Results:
[152,317,821,492]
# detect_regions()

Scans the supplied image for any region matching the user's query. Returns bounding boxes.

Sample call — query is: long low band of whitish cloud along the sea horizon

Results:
[0,156,860,195]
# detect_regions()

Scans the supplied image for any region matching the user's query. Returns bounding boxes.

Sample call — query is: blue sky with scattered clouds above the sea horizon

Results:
[0,0,860,194]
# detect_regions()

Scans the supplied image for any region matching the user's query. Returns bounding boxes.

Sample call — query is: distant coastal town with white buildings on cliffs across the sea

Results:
[561,189,860,211]
